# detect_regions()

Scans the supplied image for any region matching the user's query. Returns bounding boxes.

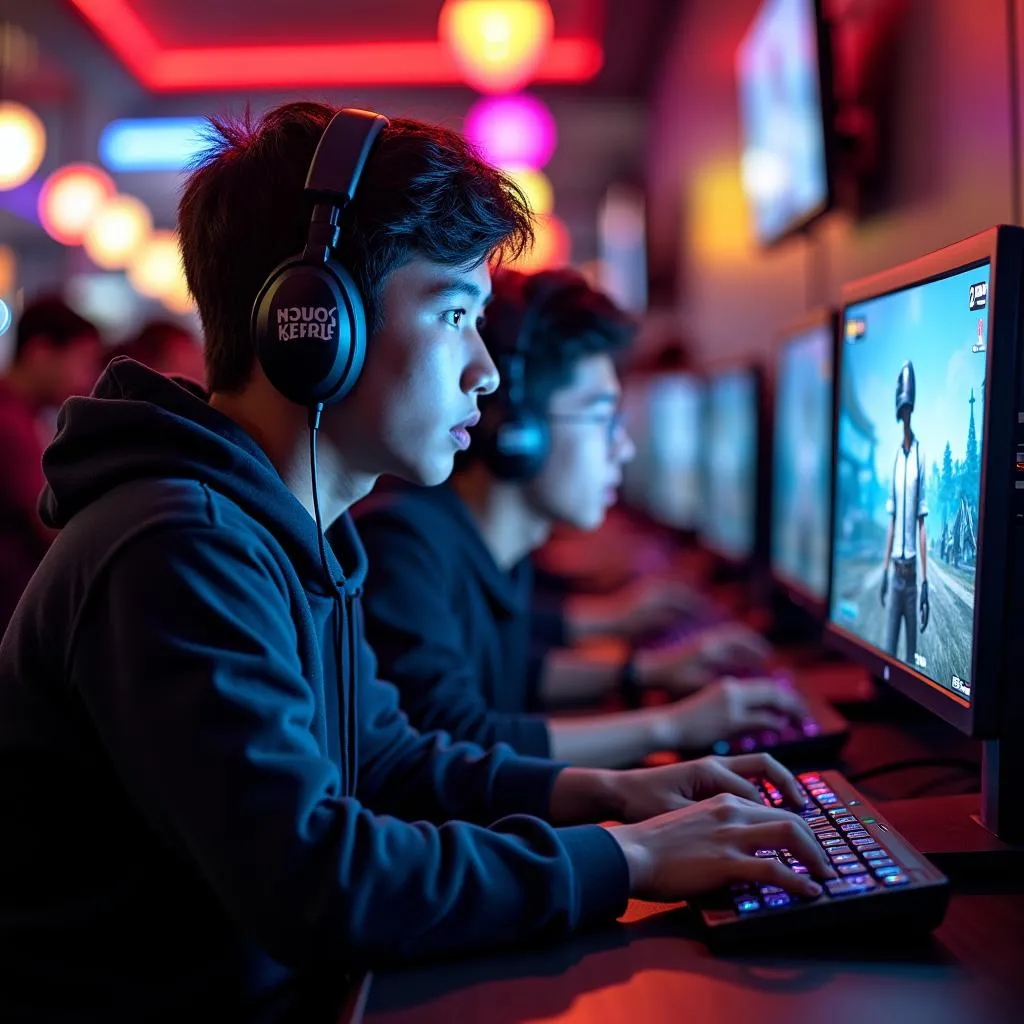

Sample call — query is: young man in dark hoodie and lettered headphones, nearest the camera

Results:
[0,103,829,1022]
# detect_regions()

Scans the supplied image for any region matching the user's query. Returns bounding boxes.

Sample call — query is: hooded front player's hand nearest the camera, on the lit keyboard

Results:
[609,794,836,901]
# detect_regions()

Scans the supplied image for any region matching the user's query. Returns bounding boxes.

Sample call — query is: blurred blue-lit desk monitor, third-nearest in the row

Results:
[698,365,761,566]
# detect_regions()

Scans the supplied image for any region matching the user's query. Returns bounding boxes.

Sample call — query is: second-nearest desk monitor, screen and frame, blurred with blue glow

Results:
[770,312,836,622]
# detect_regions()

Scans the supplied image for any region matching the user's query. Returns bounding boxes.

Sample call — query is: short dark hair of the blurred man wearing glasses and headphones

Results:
[480,268,637,416]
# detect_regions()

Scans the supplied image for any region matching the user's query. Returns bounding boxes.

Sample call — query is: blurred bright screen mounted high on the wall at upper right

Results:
[736,0,831,245]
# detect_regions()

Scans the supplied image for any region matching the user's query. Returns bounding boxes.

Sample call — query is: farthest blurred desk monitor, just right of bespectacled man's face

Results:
[623,372,703,534]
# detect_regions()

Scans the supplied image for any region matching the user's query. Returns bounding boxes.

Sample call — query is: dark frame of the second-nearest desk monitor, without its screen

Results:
[767,308,839,624]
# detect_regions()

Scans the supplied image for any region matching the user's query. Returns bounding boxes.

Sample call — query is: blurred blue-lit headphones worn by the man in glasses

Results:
[473,274,583,482]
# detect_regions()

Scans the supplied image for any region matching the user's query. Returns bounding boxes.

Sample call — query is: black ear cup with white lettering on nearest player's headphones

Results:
[251,257,367,407]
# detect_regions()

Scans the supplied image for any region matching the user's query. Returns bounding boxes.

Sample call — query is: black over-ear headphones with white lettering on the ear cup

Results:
[252,108,388,407]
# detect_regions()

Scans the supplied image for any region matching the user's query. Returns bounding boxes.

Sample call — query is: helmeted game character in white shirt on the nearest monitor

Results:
[880,362,930,666]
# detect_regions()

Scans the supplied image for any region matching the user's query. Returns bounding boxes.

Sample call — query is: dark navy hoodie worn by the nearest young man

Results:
[0,360,628,1022]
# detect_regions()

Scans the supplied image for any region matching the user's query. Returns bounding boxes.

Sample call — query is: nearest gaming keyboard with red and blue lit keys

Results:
[694,771,949,947]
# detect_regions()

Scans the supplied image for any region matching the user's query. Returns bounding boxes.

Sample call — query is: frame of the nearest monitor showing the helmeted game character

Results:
[825,225,1024,739]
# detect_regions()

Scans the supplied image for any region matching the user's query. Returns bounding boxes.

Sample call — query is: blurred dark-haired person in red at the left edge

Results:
[0,296,102,636]
